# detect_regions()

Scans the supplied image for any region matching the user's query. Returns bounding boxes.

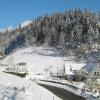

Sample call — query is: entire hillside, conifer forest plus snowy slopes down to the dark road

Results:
[0,9,100,100]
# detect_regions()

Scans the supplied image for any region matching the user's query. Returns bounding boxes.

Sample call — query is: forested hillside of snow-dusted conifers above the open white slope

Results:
[0,9,100,58]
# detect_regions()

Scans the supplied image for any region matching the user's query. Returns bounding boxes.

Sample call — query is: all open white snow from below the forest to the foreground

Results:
[0,47,84,100]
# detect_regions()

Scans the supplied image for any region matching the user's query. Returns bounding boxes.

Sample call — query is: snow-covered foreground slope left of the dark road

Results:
[0,72,61,100]
